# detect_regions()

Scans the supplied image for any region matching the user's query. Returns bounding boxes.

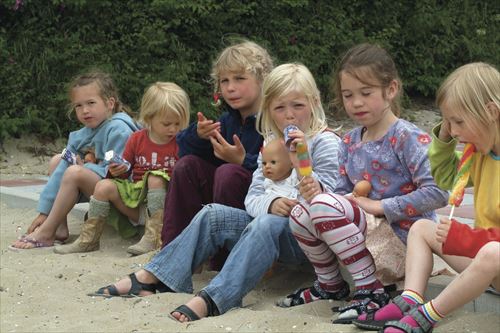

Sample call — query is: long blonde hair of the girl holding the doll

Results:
[256,63,327,139]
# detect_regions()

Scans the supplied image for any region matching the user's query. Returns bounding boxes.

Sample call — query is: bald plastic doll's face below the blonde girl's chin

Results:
[262,140,293,181]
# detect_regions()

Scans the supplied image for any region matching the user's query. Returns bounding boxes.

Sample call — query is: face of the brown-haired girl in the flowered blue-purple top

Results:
[340,72,397,128]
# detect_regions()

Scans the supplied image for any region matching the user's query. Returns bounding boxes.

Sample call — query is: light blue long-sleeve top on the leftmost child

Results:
[38,112,139,215]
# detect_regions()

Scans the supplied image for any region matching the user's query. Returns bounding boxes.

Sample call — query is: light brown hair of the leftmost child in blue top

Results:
[68,71,133,115]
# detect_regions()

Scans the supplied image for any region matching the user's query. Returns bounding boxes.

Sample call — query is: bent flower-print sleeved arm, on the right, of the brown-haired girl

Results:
[382,126,448,222]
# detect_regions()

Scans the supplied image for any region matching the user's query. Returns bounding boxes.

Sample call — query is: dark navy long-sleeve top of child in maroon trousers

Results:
[176,107,264,171]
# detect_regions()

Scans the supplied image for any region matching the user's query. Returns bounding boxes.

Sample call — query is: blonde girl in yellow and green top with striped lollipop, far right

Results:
[355,63,500,333]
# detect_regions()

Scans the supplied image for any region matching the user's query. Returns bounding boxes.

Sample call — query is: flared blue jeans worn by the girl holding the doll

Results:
[144,204,307,314]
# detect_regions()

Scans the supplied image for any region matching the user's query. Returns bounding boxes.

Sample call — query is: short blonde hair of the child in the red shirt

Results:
[139,82,189,129]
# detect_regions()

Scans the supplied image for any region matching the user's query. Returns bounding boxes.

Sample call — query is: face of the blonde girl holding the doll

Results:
[269,92,312,133]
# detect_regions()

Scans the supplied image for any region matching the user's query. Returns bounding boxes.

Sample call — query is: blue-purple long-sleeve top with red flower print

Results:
[335,119,448,244]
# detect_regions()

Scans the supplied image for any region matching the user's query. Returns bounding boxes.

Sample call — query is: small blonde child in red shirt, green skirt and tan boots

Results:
[55,82,189,255]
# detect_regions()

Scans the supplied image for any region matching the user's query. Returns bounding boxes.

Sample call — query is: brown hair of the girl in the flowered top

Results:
[333,43,403,117]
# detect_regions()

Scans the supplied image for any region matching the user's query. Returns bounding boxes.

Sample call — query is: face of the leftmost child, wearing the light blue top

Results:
[71,83,115,128]
